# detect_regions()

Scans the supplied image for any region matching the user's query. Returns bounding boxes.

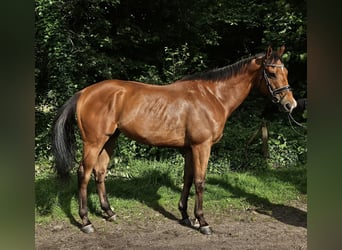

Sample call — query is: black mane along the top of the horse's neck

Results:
[180,53,265,81]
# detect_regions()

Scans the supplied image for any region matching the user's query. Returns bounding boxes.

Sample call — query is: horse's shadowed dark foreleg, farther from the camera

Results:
[178,150,194,226]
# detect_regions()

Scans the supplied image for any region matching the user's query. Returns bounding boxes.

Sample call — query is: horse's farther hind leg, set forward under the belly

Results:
[94,132,119,220]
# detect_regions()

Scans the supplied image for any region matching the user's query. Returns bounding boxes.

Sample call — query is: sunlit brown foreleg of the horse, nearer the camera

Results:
[192,141,211,234]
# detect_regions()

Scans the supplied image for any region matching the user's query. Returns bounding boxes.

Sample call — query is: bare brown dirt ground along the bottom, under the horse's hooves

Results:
[35,199,307,250]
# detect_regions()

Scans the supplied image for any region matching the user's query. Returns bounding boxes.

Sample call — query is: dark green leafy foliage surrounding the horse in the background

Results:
[35,0,306,173]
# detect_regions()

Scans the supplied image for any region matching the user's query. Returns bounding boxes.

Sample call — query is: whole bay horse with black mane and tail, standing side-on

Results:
[52,46,297,234]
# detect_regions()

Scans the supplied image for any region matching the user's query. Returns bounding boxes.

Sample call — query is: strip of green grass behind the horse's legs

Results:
[35,160,306,226]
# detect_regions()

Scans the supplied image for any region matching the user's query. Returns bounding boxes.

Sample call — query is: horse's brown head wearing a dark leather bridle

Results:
[259,46,297,113]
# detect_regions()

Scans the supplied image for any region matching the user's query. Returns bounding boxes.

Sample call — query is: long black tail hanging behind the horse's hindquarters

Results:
[52,93,79,178]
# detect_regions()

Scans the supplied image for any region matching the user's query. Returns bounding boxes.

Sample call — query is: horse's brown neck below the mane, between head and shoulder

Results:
[216,69,257,118]
